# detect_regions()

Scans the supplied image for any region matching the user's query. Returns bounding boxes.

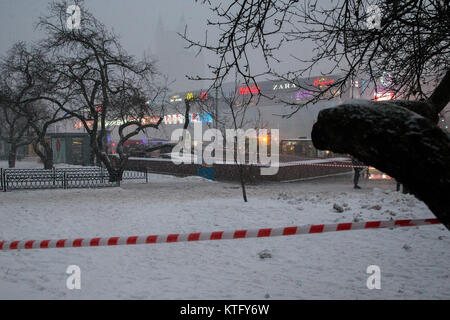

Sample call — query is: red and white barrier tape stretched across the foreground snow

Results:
[0,219,440,251]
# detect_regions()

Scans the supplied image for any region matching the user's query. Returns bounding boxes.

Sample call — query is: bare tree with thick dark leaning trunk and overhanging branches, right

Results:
[183,0,450,228]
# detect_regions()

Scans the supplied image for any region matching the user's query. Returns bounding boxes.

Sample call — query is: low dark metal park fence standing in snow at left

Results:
[0,167,148,192]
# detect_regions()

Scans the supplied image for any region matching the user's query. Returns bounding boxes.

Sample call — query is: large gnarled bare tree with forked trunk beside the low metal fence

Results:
[38,1,169,180]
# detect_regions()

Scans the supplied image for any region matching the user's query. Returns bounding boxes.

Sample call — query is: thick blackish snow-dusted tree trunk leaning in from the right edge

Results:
[311,101,450,229]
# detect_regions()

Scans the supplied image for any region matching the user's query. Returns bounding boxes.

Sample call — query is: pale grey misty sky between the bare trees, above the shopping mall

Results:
[0,0,320,91]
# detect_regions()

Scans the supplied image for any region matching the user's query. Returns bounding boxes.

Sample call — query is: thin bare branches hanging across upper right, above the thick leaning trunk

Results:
[185,0,450,108]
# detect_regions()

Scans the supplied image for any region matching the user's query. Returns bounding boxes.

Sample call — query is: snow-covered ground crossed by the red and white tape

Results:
[0,162,450,299]
